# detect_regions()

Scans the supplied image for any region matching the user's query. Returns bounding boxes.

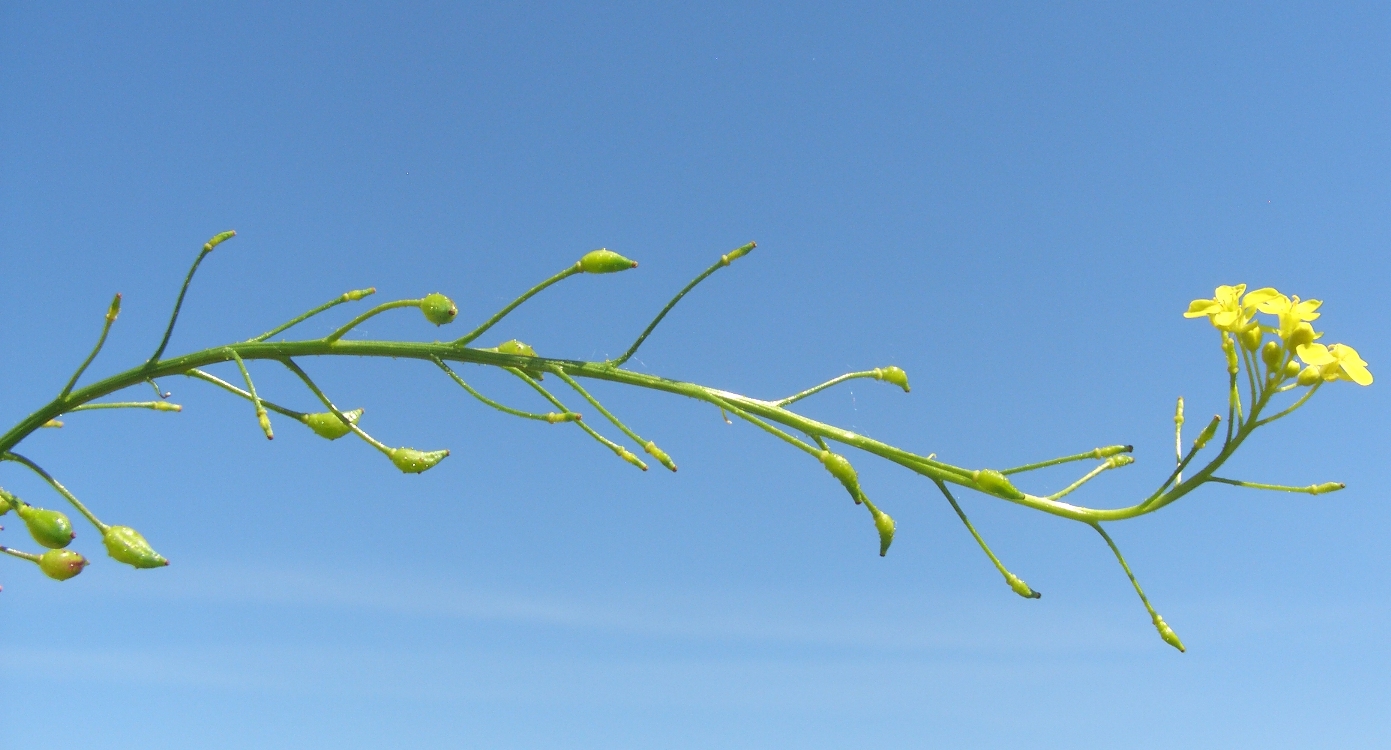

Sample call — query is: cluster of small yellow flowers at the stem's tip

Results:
[1184,284,1372,385]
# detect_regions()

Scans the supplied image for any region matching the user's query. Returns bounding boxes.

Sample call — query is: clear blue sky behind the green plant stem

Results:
[0,3,1391,750]
